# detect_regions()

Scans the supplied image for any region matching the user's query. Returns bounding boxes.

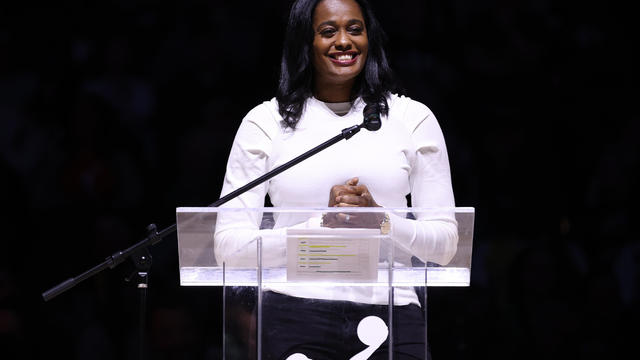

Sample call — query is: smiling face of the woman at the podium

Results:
[313,0,369,86]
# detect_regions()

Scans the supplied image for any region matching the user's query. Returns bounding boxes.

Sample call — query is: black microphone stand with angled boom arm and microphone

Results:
[42,120,380,360]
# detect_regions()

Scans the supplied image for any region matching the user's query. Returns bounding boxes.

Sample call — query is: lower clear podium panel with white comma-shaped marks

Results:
[223,285,429,360]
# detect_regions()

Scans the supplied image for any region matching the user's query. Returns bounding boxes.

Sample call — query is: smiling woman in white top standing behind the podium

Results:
[215,0,458,360]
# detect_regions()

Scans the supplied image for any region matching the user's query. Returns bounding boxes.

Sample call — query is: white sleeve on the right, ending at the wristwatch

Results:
[391,101,458,265]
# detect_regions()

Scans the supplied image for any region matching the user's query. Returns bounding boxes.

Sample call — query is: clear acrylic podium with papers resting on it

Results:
[176,207,474,360]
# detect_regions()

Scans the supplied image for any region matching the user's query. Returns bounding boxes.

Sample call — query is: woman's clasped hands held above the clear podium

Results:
[322,177,384,228]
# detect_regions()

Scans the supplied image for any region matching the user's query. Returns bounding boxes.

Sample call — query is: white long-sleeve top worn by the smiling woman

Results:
[214,95,458,305]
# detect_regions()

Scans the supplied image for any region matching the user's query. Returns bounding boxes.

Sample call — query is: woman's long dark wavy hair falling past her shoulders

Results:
[276,0,400,129]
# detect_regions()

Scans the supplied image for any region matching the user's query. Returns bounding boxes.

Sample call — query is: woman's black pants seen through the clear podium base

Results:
[262,292,427,360]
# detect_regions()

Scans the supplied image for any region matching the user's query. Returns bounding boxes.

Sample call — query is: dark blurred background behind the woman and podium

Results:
[0,0,640,360]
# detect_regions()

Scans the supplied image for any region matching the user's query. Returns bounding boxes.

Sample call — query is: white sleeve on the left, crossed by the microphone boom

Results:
[214,105,286,266]
